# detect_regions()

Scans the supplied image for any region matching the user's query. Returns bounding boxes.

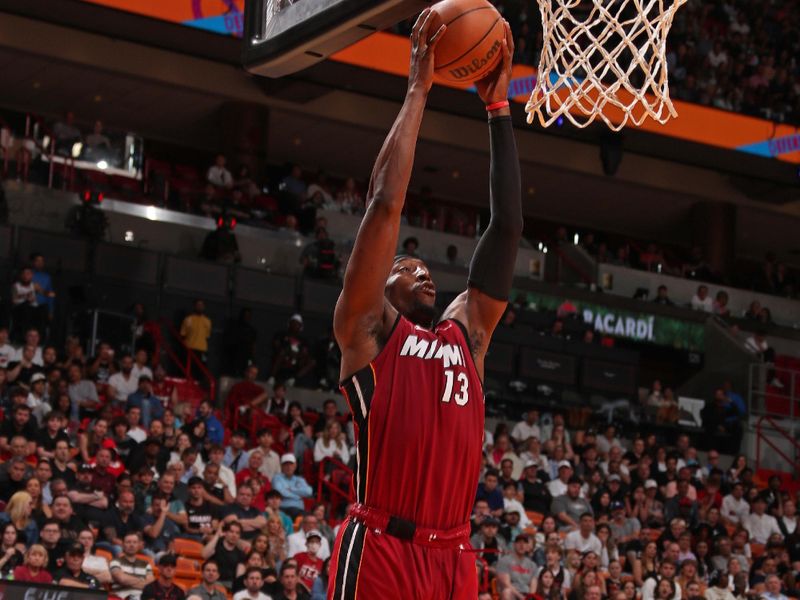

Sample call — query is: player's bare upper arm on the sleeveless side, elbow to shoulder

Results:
[333,202,400,348]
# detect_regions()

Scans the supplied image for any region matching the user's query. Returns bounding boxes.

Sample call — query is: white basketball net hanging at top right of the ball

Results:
[525,0,687,131]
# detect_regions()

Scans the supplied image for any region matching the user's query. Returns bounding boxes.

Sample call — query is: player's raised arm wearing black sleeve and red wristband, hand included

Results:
[442,22,522,377]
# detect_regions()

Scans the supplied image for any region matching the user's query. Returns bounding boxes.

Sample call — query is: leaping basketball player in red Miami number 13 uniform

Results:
[328,10,522,600]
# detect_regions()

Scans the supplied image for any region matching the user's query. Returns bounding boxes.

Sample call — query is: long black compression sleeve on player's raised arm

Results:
[469,117,522,301]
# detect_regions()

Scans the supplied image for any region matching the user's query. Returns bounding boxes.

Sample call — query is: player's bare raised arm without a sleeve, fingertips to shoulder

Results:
[333,8,445,376]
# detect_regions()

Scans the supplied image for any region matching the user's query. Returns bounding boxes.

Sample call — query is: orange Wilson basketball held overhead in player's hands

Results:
[430,0,505,83]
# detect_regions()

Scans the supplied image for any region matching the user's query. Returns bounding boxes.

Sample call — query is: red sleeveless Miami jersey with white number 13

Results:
[342,316,484,529]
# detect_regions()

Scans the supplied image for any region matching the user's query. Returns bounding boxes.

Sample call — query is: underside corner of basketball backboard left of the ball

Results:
[242,0,431,77]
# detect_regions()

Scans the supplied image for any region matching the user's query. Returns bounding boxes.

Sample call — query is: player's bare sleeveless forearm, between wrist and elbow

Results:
[367,86,428,213]
